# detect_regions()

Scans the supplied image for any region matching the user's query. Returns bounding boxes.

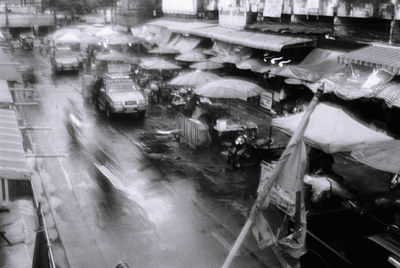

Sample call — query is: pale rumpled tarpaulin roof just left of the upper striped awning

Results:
[271,48,346,82]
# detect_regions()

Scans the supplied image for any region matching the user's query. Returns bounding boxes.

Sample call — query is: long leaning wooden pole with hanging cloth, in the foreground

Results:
[222,86,323,268]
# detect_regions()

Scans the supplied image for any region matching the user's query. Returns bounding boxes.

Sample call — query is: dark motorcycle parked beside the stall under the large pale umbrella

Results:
[227,132,282,168]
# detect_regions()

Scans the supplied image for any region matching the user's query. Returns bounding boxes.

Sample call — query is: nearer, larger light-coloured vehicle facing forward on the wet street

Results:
[92,73,148,118]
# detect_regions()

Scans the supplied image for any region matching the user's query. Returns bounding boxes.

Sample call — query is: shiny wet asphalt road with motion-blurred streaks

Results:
[10,48,274,267]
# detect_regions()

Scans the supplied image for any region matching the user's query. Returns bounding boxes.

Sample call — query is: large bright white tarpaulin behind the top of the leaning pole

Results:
[272,103,393,153]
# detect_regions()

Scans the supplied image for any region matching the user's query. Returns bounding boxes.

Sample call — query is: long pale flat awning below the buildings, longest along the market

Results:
[191,26,316,52]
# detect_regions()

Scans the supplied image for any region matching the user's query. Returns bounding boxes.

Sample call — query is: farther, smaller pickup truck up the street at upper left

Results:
[50,47,81,72]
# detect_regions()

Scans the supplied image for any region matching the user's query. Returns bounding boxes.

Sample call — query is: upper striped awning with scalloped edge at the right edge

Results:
[338,46,400,74]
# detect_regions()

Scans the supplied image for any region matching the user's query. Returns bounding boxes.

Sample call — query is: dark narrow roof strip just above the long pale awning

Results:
[248,21,332,35]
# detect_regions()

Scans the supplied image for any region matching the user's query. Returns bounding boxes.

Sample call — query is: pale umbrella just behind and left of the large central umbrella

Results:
[169,70,221,87]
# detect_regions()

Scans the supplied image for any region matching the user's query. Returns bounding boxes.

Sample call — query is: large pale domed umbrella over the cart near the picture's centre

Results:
[194,78,264,100]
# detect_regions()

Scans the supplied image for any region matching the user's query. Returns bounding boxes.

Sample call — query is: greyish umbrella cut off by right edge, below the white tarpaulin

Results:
[351,140,400,174]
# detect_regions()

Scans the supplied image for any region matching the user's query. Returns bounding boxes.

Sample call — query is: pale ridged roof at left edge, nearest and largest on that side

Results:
[0,109,29,180]
